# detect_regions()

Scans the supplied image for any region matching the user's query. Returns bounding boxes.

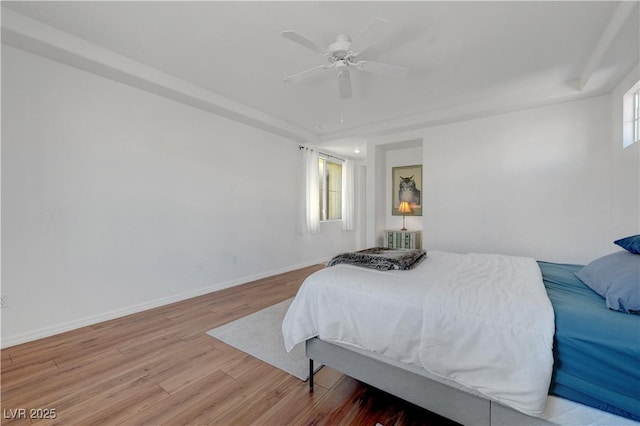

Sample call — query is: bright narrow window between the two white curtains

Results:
[318,155,342,221]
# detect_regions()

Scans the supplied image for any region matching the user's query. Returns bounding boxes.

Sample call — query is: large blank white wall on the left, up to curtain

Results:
[2,45,356,347]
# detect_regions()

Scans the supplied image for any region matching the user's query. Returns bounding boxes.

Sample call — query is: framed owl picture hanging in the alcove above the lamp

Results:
[391,164,422,216]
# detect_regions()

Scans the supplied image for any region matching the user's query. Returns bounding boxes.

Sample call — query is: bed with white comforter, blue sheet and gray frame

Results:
[283,251,640,425]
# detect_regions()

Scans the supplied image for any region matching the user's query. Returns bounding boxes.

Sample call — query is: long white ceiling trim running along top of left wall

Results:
[2,7,318,143]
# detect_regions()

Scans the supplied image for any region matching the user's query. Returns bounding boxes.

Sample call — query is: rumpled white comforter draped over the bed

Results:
[282,251,554,416]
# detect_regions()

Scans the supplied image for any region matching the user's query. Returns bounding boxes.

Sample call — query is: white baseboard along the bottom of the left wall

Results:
[0,259,328,349]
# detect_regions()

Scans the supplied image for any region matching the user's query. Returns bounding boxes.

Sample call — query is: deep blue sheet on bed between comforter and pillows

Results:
[538,262,640,420]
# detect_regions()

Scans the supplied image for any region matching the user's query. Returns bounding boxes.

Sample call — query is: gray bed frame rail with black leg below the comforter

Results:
[306,338,554,426]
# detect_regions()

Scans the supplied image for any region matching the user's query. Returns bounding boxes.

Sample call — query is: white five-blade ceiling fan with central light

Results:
[282,18,409,99]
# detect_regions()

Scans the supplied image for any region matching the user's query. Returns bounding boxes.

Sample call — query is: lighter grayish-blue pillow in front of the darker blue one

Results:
[576,251,640,314]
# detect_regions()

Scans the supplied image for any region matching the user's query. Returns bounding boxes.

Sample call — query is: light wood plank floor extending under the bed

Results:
[1,266,458,426]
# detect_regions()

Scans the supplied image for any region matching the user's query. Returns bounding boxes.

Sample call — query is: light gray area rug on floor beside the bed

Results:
[207,299,321,381]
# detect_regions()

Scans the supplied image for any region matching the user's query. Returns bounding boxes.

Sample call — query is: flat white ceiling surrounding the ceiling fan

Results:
[2,1,640,156]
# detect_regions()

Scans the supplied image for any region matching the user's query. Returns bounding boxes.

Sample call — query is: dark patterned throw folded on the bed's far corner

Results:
[327,247,427,271]
